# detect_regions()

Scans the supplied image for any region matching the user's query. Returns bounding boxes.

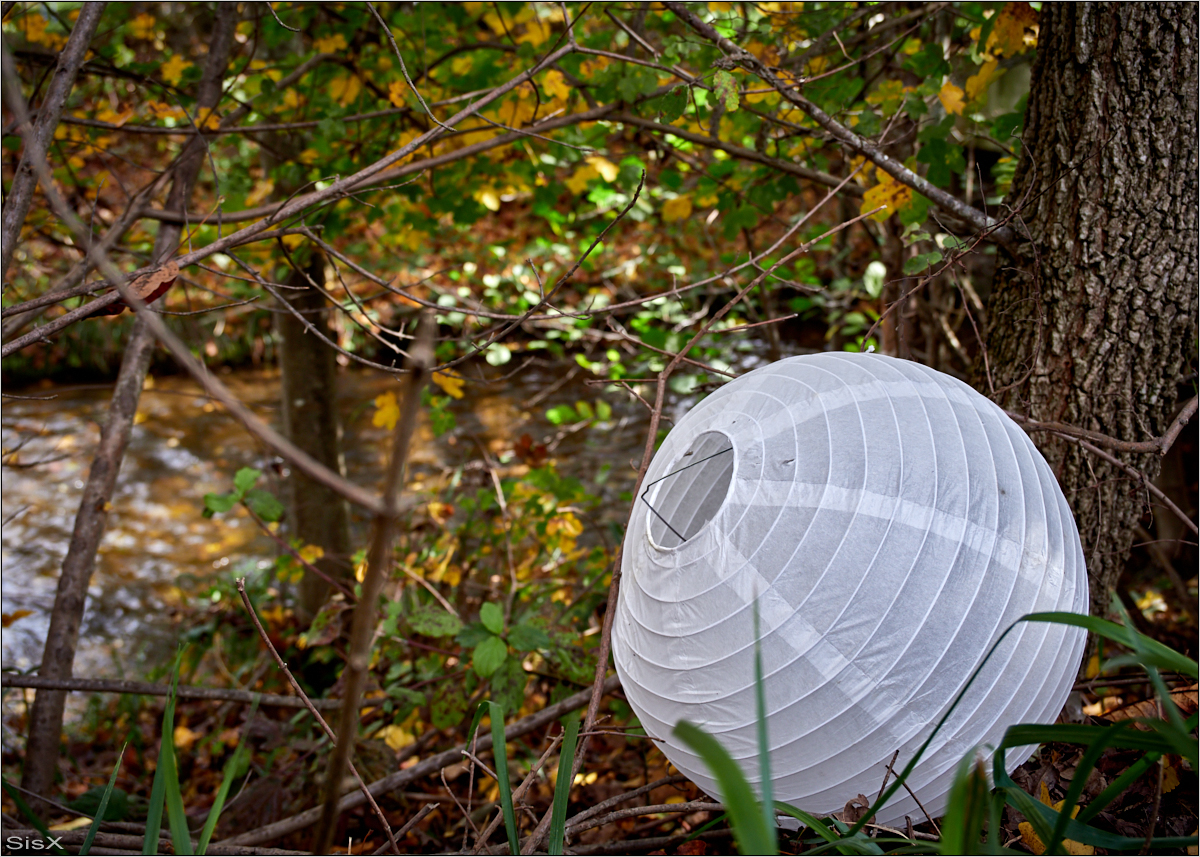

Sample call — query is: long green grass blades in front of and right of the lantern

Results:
[674,604,1200,855]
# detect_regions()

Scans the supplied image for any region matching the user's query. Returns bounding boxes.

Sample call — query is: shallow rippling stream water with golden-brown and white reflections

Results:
[2,367,667,678]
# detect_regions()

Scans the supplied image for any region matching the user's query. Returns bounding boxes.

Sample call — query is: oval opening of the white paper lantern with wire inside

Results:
[642,431,734,549]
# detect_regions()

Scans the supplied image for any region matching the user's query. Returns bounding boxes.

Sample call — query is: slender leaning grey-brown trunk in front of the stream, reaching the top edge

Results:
[22,4,238,796]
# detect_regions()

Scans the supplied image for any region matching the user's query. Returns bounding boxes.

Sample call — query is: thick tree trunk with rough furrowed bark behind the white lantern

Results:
[976,4,1200,616]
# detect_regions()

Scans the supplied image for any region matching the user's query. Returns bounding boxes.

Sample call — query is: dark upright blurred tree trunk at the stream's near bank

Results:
[276,253,350,622]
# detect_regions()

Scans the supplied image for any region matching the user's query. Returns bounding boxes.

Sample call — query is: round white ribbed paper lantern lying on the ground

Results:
[612,353,1088,823]
